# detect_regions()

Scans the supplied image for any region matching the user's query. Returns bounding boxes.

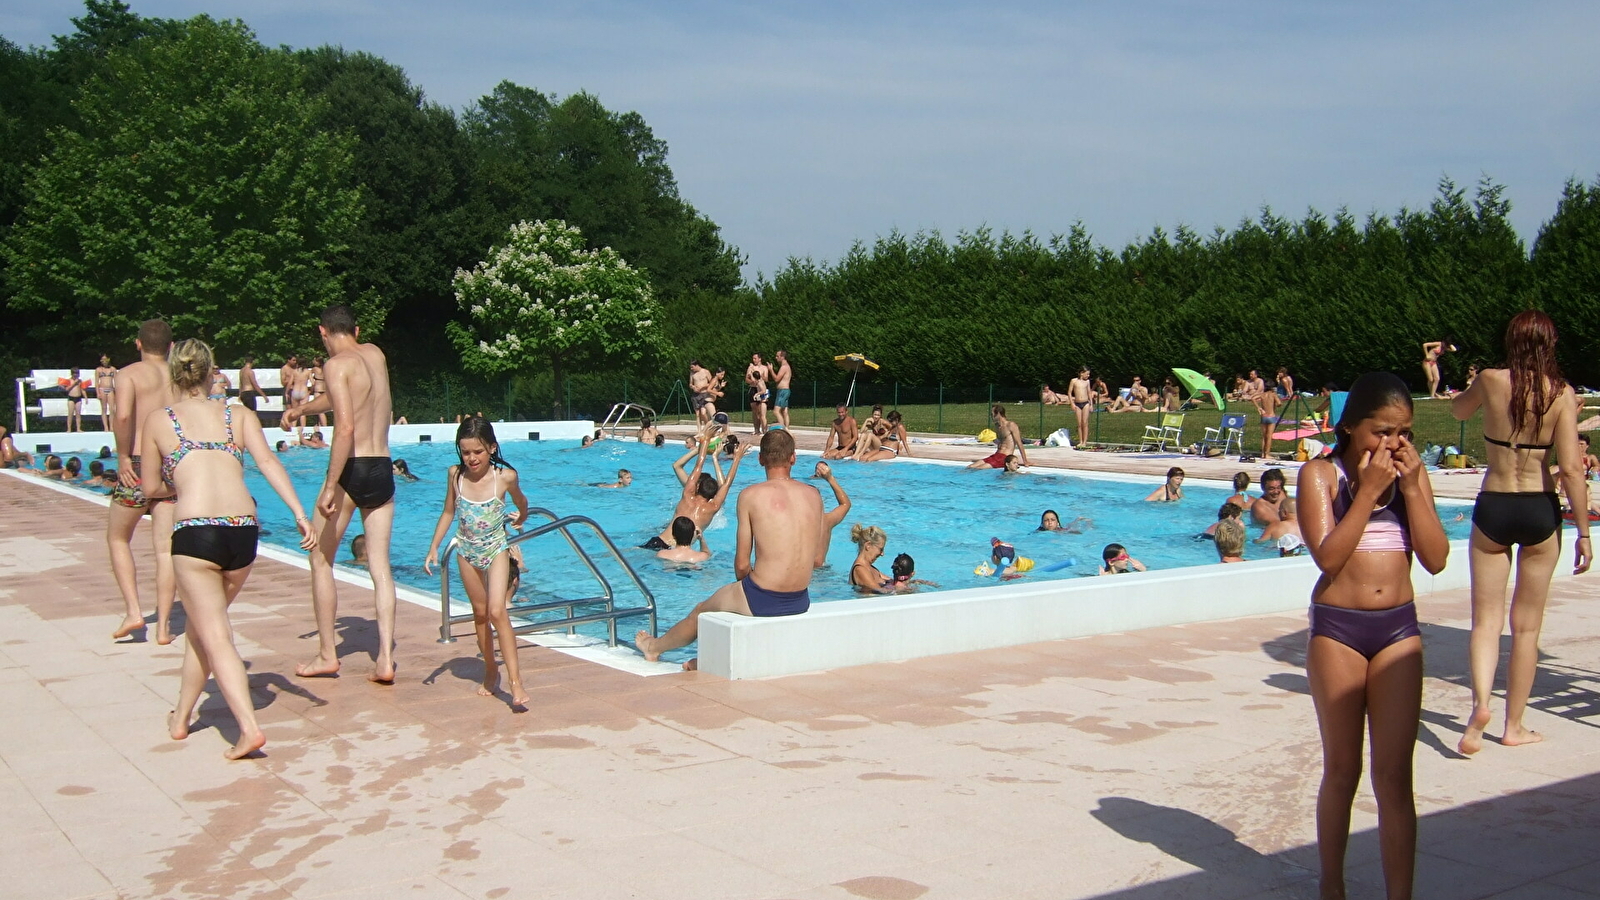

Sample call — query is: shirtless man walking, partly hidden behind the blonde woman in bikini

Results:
[106,319,178,644]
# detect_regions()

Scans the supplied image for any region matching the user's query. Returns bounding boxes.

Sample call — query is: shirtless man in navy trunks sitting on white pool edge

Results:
[634,431,822,669]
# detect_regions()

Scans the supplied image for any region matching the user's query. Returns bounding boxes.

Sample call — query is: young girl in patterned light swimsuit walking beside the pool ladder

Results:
[422,416,528,713]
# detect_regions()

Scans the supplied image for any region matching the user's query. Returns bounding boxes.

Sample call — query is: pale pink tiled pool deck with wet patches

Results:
[0,470,1600,900]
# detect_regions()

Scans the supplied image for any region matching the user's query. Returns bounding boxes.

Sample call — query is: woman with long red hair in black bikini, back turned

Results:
[1450,309,1594,754]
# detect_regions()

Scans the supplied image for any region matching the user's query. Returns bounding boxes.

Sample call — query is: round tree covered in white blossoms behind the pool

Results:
[446,219,667,410]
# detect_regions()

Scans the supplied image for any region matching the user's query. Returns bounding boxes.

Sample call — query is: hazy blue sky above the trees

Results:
[0,0,1600,277]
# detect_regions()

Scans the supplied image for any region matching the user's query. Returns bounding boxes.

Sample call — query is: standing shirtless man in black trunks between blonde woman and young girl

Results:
[283,306,395,684]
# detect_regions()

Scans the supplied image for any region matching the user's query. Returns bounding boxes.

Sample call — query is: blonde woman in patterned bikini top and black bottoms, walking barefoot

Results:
[141,341,317,759]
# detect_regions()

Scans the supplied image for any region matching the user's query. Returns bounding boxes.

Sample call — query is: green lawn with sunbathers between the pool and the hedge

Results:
[666,400,1483,460]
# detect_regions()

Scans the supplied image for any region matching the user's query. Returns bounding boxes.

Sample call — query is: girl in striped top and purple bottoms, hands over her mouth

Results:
[1296,372,1450,897]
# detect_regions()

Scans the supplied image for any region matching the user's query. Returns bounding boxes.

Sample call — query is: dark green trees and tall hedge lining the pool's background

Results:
[0,0,1600,422]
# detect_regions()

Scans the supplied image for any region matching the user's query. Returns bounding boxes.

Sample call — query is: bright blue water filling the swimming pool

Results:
[59,440,1470,656]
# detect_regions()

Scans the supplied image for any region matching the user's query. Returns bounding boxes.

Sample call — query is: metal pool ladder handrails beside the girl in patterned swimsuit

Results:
[438,506,656,647]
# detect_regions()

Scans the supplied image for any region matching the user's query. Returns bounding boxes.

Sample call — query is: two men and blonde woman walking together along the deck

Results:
[89,306,395,759]
